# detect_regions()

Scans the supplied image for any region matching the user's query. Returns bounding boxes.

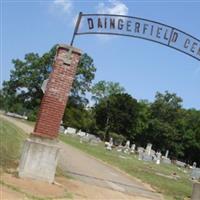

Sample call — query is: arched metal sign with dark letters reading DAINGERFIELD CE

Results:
[71,12,200,61]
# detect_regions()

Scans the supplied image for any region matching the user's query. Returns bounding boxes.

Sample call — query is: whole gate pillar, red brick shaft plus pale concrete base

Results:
[19,45,81,183]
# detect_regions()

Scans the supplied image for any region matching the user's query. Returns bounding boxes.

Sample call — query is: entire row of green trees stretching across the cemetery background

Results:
[0,46,200,164]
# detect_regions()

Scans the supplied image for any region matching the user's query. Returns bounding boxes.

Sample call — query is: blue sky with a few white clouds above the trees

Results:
[1,0,200,110]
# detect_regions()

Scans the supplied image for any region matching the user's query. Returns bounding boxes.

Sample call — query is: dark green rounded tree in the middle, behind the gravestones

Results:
[95,93,138,139]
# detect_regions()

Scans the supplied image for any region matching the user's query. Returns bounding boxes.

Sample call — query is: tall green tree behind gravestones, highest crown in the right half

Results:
[143,91,184,157]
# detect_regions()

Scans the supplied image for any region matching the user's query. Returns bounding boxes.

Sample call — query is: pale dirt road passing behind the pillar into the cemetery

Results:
[0,115,162,200]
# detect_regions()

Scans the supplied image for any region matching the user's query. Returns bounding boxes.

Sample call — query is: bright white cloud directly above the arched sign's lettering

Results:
[97,0,128,15]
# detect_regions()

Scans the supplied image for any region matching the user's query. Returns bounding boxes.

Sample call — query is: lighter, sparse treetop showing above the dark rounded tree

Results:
[91,81,125,103]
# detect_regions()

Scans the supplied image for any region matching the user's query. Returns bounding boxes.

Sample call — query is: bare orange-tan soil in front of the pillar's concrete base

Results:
[0,173,151,200]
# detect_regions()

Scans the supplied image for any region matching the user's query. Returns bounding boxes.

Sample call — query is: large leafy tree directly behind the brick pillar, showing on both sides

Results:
[3,46,96,119]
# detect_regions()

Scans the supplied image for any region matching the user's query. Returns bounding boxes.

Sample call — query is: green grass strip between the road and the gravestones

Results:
[60,135,192,200]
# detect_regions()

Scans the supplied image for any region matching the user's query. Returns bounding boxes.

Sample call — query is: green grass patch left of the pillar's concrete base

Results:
[0,118,27,169]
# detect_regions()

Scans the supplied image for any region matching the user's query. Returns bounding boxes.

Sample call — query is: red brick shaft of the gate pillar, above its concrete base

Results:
[32,45,81,139]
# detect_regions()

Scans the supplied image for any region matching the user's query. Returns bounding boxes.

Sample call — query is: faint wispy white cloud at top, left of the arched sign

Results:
[52,0,72,14]
